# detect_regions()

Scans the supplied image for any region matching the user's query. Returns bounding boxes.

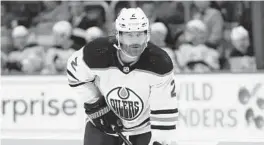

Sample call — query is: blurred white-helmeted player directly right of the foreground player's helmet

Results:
[150,22,177,72]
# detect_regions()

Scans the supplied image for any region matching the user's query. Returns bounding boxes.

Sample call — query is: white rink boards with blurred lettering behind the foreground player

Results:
[0,73,264,145]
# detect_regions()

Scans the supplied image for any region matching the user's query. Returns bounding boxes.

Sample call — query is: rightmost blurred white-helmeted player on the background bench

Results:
[229,26,256,72]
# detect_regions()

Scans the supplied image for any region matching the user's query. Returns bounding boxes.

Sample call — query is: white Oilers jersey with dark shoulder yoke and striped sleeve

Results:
[67,37,178,135]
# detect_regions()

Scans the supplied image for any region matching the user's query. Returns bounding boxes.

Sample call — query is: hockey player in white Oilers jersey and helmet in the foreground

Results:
[67,8,178,145]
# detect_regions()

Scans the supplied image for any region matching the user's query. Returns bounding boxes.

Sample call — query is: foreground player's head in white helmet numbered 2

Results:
[115,8,150,58]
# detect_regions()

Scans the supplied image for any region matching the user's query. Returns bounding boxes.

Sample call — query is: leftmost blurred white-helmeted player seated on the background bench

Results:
[6,26,44,74]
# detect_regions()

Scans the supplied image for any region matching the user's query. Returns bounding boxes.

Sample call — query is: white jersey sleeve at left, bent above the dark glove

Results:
[67,48,100,103]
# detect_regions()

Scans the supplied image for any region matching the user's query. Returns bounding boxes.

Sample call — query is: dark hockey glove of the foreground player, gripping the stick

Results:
[84,97,123,134]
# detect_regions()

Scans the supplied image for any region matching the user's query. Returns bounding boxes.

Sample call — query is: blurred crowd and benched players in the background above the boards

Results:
[1,1,256,75]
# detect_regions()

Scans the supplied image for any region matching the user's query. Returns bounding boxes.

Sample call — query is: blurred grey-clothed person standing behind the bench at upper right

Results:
[193,1,224,48]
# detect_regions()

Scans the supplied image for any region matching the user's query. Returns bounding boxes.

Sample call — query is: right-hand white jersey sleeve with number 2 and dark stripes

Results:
[150,72,178,143]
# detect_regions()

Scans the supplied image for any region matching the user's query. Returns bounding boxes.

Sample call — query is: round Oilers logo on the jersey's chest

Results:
[106,87,144,121]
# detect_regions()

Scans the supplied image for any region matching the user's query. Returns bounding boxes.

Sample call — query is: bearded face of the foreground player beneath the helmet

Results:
[120,31,147,57]
